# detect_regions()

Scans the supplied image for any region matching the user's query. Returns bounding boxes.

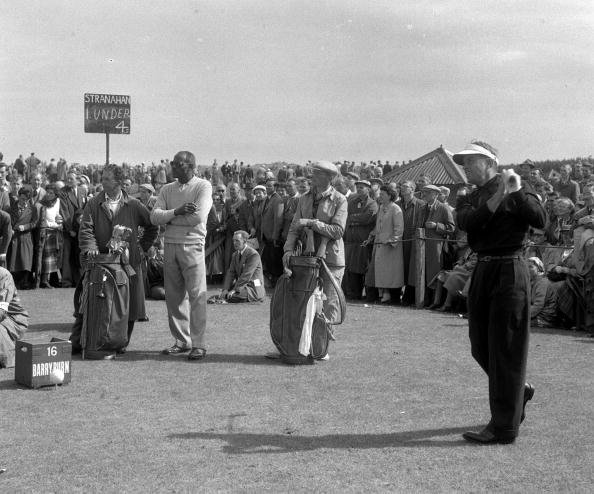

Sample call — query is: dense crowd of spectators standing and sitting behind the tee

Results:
[0,153,594,334]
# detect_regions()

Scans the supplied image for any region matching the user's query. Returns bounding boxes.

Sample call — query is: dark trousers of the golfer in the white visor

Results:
[468,259,530,437]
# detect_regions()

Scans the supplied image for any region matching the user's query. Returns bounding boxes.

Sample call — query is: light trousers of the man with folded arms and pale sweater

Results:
[163,243,206,349]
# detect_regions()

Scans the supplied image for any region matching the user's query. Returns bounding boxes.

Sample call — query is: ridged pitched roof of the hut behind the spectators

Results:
[383,146,466,202]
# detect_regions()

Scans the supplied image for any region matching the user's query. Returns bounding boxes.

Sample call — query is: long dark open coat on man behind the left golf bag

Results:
[78,191,159,321]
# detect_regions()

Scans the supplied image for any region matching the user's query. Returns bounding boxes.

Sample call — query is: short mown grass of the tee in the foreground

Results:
[0,289,594,493]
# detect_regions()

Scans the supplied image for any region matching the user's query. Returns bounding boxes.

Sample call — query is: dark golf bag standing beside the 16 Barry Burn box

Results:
[80,253,132,358]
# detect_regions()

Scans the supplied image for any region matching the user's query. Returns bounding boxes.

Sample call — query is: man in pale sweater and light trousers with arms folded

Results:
[151,151,212,360]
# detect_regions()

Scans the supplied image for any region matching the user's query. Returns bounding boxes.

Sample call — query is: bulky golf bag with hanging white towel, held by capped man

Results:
[270,231,346,365]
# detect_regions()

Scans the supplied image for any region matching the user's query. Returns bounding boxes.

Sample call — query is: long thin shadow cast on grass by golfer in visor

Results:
[167,424,484,454]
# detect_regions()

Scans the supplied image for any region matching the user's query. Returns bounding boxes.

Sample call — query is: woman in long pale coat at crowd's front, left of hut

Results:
[364,185,404,304]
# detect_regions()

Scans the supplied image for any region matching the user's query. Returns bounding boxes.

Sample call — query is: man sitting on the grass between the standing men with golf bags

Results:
[221,230,266,303]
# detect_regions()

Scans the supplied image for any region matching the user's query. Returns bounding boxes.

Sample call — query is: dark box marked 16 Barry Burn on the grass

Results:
[14,337,72,388]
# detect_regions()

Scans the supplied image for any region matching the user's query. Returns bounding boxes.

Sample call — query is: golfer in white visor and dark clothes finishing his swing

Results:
[453,141,547,444]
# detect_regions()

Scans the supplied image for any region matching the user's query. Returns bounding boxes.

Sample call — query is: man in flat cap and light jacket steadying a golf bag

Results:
[283,161,348,342]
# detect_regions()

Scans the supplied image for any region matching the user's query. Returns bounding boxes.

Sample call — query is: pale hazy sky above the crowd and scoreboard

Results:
[0,0,594,164]
